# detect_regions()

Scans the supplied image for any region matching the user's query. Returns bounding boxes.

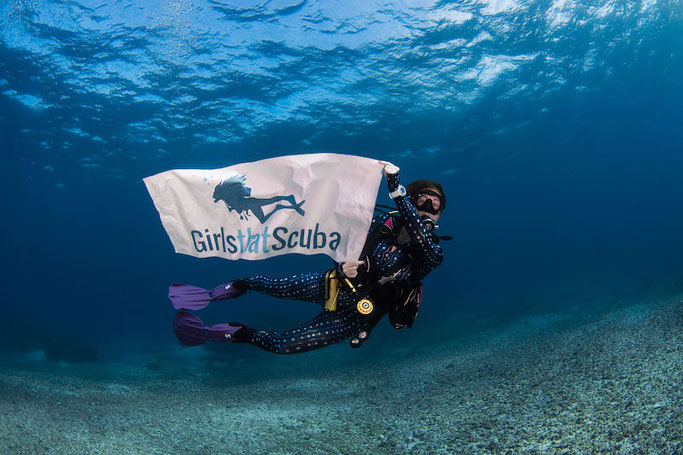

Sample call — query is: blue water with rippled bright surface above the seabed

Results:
[0,0,683,358]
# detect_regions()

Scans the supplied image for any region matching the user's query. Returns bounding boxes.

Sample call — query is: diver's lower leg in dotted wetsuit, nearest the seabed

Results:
[248,305,360,354]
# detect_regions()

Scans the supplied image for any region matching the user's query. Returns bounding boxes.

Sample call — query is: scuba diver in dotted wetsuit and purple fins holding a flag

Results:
[169,162,450,354]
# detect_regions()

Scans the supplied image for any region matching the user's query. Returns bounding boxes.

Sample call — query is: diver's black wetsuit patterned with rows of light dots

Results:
[239,174,443,354]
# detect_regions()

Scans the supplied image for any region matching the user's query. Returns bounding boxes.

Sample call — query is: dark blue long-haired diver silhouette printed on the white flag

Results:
[213,175,306,224]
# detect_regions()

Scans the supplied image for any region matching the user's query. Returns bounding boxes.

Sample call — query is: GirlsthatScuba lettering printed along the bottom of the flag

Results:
[190,223,341,254]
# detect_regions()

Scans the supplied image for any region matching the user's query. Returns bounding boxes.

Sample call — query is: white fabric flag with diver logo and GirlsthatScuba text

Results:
[144,153,383,262]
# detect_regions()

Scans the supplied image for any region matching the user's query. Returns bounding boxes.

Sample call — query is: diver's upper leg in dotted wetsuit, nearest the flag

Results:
[240,272,325,305]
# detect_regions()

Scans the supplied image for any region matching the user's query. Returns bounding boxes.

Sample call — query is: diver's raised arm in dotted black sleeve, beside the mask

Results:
[385,168,443,269]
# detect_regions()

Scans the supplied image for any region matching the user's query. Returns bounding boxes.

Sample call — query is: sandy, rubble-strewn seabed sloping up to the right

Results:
[0,295,683,455]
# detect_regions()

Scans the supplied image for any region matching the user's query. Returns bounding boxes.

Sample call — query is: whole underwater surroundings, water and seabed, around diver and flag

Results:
[0,0,683,453]
